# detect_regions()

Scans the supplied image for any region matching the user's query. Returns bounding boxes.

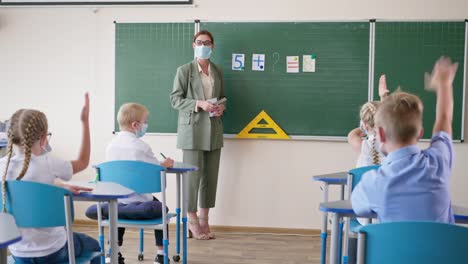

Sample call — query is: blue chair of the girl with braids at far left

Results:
[0,180,101,264]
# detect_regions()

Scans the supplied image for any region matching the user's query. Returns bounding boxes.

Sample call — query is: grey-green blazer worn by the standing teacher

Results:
[170,59,224,151]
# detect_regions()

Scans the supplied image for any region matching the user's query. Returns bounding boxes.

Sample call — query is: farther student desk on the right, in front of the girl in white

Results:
[312,171,348,264]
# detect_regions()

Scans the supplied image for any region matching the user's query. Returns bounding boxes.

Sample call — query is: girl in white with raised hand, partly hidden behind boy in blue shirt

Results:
[348,75,388,167]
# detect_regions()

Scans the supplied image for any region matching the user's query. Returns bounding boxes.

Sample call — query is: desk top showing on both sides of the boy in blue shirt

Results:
[320,200,468,224]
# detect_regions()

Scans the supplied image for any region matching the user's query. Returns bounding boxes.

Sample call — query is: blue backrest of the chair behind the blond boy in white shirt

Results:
[95,160,164,193]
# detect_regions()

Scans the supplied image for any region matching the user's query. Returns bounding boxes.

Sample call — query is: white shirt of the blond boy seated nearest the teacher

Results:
[106,131,159,204]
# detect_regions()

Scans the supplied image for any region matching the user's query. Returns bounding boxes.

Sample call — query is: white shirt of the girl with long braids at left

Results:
[0,152,73,258]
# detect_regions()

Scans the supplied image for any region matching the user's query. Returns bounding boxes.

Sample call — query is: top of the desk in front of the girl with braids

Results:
[66,181,135,199]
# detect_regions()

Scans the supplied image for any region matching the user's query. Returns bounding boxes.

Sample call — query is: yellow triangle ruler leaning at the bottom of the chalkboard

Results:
[236,110,289,139]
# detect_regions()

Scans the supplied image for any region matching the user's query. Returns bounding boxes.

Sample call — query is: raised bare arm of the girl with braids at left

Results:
[71,93,91,174]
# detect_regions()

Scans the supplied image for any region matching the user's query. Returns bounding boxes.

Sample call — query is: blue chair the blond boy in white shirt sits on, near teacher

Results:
[95,160,176,263]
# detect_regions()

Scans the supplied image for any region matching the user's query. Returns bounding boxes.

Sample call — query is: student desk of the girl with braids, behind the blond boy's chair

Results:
[71,181,134,263]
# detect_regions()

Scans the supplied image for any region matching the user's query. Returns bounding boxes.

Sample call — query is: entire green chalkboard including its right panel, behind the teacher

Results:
[115,22,465,139]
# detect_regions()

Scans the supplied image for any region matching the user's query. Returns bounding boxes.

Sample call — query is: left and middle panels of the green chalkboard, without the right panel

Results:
[115,22,369,136]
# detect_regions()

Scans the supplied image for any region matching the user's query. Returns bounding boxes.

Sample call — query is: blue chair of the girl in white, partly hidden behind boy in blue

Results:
[343,165,380,264]
